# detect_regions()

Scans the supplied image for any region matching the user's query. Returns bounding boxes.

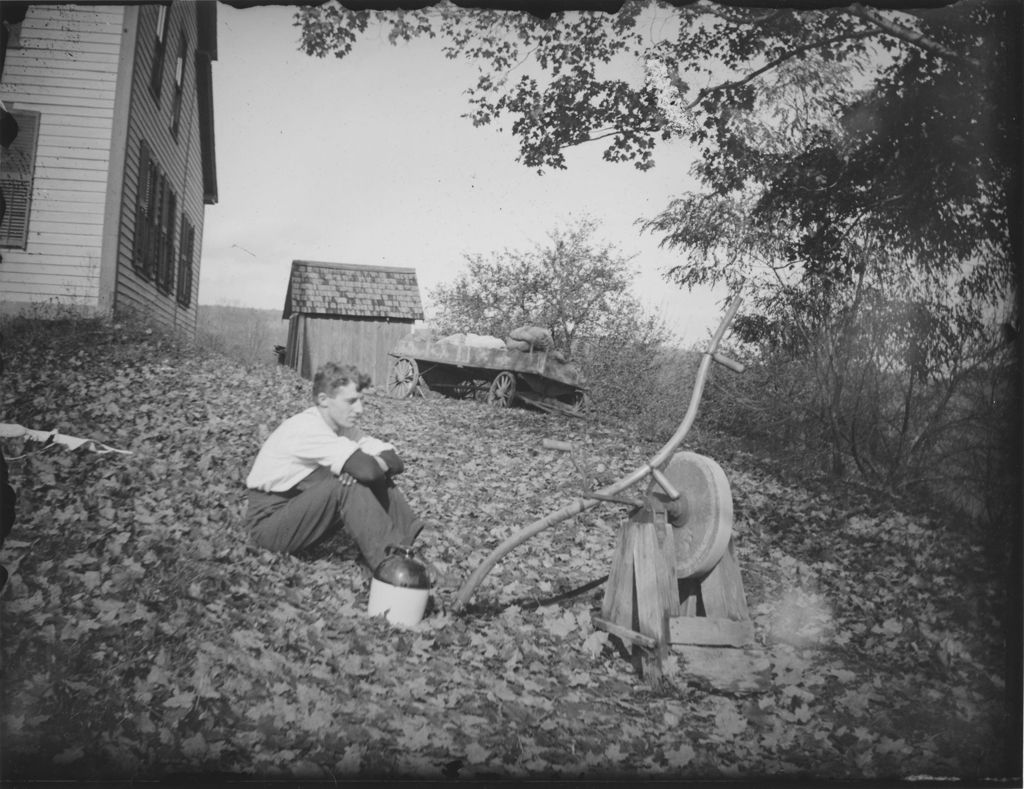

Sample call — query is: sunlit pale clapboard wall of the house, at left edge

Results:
[0,3,125,308]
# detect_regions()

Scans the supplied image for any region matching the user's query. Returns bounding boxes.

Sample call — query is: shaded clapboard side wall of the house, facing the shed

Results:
[115,3,205,337]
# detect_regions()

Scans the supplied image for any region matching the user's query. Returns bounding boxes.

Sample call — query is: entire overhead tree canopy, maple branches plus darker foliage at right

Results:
[296,0,1020,315]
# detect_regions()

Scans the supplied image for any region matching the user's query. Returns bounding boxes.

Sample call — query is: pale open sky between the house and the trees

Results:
[200,4,723,343]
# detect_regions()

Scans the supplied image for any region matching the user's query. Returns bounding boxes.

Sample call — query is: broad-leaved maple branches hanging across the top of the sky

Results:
[296,0,1019,185]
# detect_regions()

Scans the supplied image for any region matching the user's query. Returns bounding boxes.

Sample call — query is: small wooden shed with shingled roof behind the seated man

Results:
[284,260,423,386]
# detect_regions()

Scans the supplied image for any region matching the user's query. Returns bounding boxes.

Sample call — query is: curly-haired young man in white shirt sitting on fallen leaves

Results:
[245,362,423,570]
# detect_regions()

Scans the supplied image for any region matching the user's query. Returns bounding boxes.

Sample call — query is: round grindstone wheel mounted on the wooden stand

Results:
[652,452,732,578]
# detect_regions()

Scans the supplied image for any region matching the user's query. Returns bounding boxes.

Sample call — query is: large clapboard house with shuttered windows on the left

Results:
[0,1,217,336]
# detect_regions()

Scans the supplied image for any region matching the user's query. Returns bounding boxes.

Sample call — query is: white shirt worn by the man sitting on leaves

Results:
[246,405,394,493]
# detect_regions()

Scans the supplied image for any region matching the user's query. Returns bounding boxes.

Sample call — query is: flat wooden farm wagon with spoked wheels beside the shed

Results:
[387,335,587,415]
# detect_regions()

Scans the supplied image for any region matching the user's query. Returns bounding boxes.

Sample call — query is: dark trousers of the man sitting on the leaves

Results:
[246,467,423,568]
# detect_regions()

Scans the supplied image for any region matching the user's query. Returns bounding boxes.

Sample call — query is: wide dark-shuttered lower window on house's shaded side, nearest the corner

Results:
[132,140,177,295]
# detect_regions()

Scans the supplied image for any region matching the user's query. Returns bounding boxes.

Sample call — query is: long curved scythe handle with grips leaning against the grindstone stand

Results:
[453,296,743,611]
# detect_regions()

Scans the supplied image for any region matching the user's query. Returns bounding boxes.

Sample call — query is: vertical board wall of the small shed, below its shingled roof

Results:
[288,314,413,388]
